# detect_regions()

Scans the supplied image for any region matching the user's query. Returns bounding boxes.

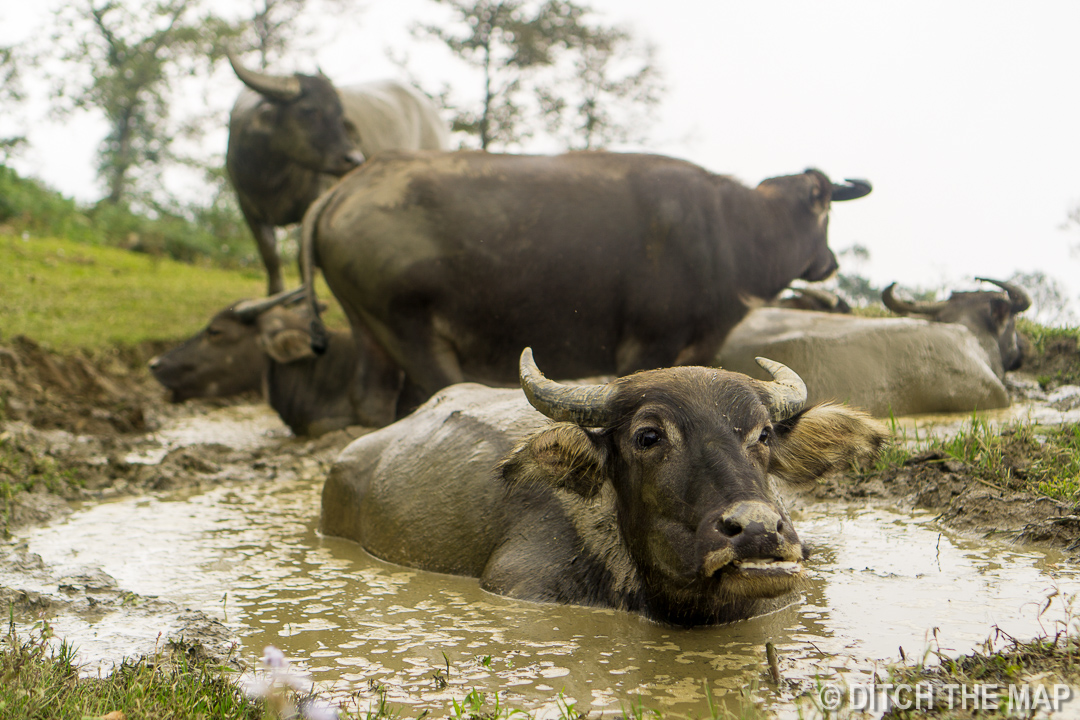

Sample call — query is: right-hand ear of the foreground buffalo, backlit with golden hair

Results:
[769,403,889,484]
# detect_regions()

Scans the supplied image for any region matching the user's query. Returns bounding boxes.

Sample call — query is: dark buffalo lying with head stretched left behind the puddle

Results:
[150,288,356,436]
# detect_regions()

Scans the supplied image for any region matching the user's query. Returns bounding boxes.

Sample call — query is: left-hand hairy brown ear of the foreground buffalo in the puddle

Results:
[496,422,607,498]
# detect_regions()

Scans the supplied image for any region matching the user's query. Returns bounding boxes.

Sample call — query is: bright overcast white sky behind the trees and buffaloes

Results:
[0,0,1080,321]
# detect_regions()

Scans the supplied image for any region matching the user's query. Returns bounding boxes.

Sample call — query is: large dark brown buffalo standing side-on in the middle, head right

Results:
[301,152,870,425]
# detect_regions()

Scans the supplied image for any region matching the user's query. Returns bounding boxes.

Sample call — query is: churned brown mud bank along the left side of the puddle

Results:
[0,337,354,664]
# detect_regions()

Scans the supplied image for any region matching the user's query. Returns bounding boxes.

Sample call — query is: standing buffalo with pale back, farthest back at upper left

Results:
[225,54,449,294]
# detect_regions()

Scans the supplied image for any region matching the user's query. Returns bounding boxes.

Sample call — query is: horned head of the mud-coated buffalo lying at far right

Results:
[881,277,1031,376]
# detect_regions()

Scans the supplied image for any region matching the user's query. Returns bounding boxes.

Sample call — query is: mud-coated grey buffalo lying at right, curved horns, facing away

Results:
[715,281,1029,417]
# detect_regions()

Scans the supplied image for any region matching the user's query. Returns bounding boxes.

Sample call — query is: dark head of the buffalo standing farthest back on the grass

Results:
[229,53,364,176]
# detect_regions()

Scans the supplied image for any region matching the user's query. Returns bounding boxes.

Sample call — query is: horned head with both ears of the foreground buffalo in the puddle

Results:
[500,350,886,624]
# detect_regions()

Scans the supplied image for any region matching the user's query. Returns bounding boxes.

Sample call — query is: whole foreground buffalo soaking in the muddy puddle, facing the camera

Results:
[321,350,886,625]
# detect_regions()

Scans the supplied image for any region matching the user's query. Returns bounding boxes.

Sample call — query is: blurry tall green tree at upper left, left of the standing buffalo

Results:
[45,0,237,205]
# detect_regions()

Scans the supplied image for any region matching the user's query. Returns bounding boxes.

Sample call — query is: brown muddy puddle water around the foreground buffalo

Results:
[6,407,1080,717]
